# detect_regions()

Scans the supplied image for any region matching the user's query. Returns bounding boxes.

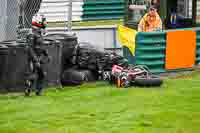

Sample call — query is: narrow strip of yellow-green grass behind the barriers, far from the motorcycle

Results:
[48,19,123,28]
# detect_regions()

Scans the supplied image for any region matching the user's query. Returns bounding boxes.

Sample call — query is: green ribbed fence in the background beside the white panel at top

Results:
[82,0,124,21]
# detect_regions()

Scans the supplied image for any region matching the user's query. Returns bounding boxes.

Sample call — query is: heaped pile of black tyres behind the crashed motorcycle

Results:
[77,43,127,71]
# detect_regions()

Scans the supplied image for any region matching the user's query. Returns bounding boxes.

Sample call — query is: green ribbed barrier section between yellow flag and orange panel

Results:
[135,32,166,73]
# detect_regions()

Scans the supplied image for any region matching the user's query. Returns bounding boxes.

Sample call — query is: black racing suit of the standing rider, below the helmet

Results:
[25,30,50,95]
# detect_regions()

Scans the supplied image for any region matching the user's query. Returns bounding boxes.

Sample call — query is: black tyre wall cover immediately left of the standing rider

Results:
[5,45,28,91]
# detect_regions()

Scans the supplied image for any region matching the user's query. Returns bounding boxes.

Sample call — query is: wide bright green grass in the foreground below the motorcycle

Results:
[0,72,200,133]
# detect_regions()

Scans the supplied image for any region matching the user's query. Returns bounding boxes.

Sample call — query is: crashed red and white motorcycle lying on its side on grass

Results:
[103,65,163,88]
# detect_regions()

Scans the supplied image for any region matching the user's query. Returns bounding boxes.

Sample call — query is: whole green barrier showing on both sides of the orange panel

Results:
[124,28,200,73]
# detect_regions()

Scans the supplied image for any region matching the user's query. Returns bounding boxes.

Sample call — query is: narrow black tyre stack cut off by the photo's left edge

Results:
[0,44,9,92]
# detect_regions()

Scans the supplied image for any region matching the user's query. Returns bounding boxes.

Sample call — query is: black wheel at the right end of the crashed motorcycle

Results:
[134,76,163,86]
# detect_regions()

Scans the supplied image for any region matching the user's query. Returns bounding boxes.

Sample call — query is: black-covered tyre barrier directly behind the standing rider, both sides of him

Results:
[0,39,62,92]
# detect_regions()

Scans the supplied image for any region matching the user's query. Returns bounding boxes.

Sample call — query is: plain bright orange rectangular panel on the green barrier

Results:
[165,30,196,70]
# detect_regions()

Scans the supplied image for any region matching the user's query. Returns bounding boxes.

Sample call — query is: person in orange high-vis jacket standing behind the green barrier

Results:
[138,6,162,32]
